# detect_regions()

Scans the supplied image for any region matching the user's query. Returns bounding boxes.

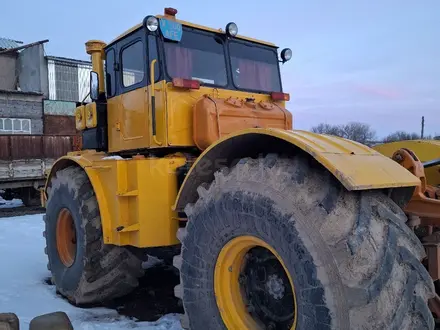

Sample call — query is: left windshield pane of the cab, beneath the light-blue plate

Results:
[164,28,228,86]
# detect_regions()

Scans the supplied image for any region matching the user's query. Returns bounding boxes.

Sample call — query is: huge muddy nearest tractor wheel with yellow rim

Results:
[175,155,434,330]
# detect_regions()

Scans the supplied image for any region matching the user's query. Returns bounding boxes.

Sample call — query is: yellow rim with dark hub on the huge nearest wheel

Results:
[214,236,297,330]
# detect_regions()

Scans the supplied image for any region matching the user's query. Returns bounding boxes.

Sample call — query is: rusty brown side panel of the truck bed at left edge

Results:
[0,135,81,161]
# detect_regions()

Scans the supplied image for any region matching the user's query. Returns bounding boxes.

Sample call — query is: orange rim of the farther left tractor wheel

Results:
[56,208,76,267]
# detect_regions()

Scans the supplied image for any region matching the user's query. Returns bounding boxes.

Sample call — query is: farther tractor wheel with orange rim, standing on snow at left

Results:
[44,167,143,305]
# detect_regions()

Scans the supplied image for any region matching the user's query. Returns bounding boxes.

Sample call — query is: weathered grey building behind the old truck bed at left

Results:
[0,38,91,135]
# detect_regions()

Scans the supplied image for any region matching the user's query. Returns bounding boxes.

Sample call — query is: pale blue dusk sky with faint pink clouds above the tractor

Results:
[0,0,440,138]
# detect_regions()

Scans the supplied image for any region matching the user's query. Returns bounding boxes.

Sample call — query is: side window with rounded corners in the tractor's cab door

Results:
[122,41,145,87]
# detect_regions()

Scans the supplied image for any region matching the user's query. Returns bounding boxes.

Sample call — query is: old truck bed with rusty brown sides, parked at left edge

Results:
[0,135,81,206]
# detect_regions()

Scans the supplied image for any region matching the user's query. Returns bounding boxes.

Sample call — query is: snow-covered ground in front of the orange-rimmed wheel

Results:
[0,211,181,330]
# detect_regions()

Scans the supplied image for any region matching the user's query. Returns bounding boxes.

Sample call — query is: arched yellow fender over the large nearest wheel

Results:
[174,128,420,210]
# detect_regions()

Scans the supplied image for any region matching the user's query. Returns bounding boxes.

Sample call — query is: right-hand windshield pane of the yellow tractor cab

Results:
[229,42,281,92]
